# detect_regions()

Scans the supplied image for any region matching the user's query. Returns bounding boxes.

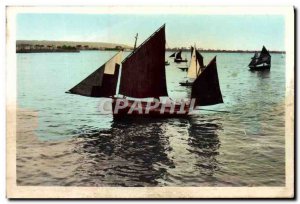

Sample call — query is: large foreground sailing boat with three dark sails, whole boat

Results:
[69,25,223,118]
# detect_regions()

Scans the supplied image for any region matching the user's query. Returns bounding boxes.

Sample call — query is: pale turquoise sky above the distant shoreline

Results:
[16,13,285,50]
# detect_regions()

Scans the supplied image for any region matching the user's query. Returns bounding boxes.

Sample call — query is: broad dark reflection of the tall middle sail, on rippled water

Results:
[73,120,174,186]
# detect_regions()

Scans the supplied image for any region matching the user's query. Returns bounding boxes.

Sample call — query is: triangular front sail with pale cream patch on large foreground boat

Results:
[68,52,121,97]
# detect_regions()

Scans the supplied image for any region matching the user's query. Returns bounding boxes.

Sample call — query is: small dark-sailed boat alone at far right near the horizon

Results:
[248,46,271,70]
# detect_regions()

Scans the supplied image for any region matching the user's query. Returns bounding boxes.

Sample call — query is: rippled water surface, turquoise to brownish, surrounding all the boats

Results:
[17,51,285,186]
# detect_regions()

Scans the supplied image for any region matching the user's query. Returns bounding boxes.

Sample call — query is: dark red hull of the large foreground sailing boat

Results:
[112,98,190,118]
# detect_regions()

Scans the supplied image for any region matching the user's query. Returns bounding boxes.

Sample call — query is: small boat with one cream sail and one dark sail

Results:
[179,46,205,86]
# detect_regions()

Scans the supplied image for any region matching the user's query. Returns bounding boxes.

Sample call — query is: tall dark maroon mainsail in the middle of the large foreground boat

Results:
[119,25,168,98]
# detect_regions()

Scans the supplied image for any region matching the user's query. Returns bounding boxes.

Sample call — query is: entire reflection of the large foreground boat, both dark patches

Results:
[52,116,220,186]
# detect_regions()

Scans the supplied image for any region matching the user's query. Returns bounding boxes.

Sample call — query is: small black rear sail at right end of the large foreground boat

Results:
[192,57,223,106]
